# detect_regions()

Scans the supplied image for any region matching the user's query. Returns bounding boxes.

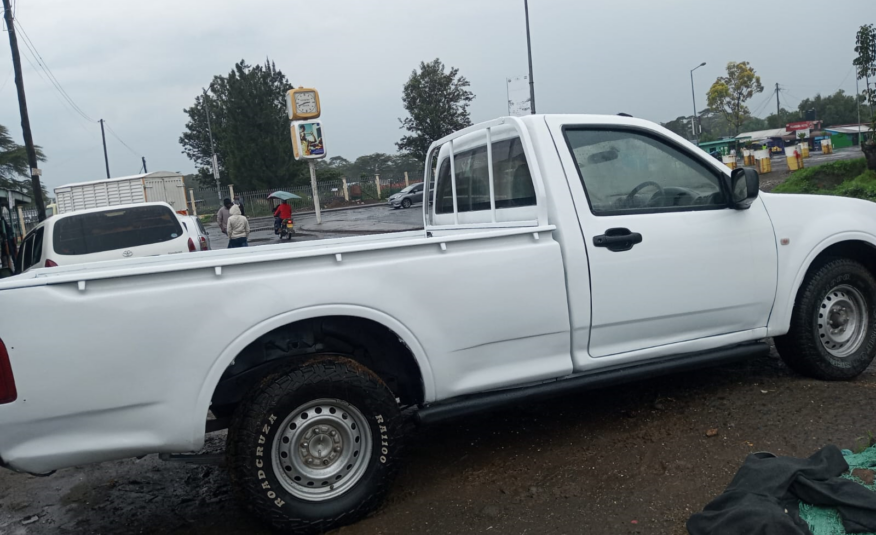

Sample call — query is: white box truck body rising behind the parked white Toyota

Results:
[55,171,188,214]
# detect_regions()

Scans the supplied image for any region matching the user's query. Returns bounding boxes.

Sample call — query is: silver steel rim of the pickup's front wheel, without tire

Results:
[816,284,869,358]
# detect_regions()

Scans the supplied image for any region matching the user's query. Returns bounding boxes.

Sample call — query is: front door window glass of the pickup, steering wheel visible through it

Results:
[565,128,727,215]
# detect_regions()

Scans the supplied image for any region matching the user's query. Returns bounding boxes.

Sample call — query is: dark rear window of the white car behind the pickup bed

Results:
[52,206,183,255]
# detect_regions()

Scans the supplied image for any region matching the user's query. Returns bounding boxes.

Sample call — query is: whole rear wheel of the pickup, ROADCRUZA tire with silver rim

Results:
[227,356,402,534]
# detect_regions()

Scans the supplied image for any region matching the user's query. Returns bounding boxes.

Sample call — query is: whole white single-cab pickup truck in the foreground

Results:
[0,115,876,533]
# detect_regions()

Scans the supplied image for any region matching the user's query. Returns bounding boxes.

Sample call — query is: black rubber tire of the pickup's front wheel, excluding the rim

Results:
[775,258,876,381]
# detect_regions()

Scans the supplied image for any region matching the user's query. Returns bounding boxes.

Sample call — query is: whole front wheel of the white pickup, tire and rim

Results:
[775,258,876,381]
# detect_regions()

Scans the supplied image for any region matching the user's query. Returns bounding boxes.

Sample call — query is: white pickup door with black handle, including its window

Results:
[547,117,776,362]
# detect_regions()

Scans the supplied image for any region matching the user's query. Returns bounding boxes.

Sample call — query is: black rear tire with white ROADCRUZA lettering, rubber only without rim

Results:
[226,356,403,535]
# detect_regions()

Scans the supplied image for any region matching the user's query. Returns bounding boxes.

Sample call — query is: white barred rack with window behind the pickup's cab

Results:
[423,117,548,232]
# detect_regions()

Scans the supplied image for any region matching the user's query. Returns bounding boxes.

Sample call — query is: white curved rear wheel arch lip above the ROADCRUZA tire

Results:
[194,304,435,443]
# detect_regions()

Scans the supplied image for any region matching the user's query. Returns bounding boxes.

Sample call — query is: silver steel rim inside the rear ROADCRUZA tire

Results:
[271,399,372,501]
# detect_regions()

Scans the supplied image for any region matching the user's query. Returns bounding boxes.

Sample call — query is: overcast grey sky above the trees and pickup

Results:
[0,0,876,193]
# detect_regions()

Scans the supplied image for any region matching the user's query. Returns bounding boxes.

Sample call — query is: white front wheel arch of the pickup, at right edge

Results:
[769,232,876,336]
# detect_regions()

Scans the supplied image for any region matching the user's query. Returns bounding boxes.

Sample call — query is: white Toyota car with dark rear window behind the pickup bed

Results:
[15,202,197,273]
